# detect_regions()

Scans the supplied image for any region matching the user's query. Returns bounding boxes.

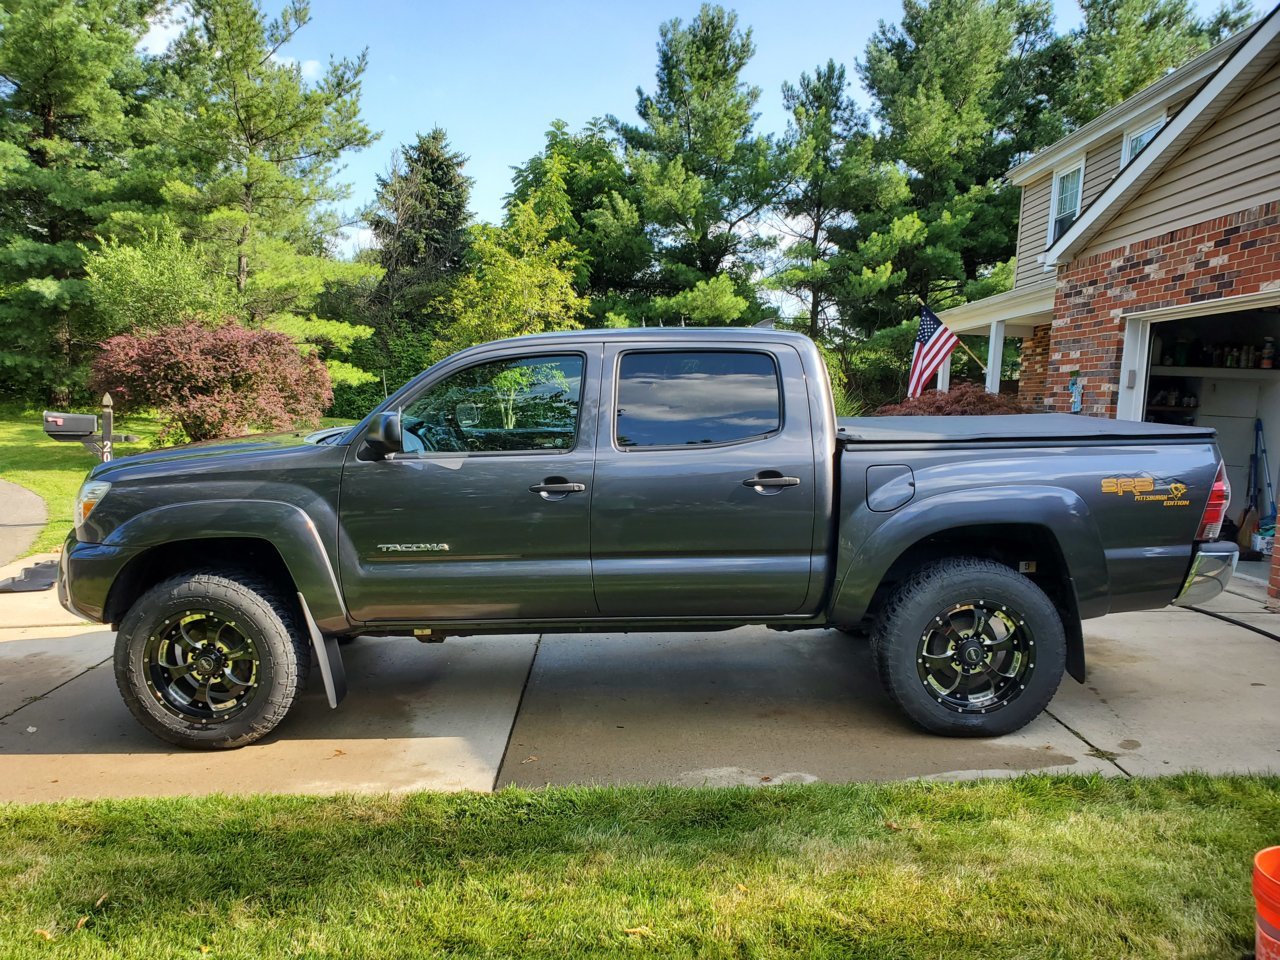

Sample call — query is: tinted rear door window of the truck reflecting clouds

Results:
[614,351,782,447]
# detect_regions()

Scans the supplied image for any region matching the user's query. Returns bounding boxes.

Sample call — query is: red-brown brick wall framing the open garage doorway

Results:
[1039,202,1280,417]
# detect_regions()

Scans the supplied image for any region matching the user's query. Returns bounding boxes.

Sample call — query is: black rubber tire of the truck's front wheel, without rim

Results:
[115,571,311,750]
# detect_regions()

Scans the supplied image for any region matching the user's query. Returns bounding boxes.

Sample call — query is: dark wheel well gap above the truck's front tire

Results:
[102,536,294,628]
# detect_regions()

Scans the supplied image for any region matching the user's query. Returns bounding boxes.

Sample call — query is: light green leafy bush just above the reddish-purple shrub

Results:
[84,232,237,339]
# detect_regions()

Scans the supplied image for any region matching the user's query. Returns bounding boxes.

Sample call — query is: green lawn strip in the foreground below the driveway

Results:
[0,778,1280,960]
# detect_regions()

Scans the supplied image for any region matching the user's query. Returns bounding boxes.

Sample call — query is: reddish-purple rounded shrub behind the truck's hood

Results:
[91,321,333,440]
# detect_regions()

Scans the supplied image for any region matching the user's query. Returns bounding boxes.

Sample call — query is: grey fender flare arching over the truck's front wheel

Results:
[102,499,352,634]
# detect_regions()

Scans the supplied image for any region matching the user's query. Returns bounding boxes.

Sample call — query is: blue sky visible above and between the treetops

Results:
[145,0,1233,246]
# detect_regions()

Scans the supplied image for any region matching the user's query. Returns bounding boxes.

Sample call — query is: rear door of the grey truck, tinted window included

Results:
[591,342,814,617]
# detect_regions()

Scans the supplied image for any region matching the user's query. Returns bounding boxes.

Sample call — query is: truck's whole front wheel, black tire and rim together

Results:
[115,572,311,750]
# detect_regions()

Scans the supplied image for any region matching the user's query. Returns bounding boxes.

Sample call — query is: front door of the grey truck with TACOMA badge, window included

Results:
[339,346,599,622]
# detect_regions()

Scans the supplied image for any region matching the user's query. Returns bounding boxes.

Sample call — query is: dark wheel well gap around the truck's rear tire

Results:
[868,524,1084,684]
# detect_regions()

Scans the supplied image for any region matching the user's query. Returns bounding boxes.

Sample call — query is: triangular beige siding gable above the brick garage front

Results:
[1078,55,1280,256]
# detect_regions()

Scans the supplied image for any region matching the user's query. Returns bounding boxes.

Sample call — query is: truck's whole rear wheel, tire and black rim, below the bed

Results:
[872,557,1066,737]
